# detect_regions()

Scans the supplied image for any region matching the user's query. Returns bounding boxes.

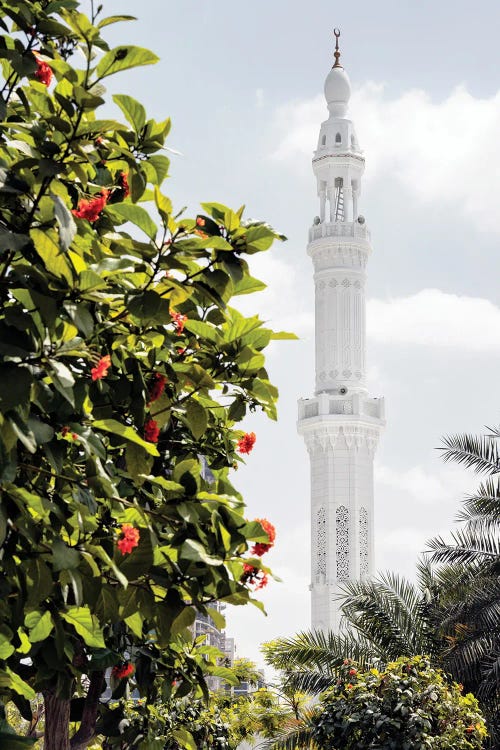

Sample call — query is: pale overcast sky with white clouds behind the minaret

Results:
[104,0,500,662]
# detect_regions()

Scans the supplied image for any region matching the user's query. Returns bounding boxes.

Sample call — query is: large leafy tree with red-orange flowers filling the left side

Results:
[0,0,287,750]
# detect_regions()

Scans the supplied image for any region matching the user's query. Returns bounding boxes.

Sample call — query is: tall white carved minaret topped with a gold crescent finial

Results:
[298,29,384,631]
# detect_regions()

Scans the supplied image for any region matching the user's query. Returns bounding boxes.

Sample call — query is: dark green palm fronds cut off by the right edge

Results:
[429,429,500,747]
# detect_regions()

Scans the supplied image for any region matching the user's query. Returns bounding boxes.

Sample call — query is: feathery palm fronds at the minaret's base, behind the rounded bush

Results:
[264,562,444,695]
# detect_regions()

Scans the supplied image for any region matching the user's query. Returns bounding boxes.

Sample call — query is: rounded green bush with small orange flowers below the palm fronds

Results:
[273,656,486,750]
